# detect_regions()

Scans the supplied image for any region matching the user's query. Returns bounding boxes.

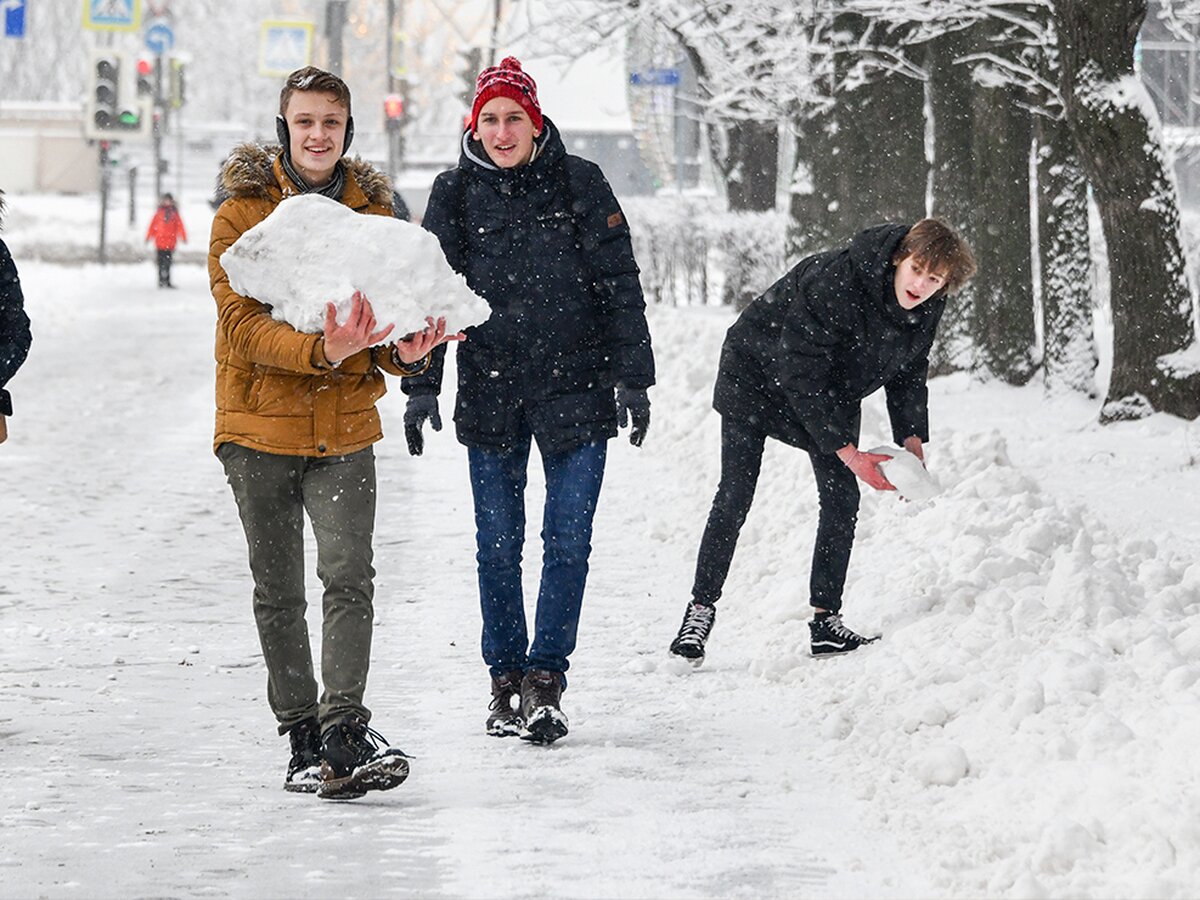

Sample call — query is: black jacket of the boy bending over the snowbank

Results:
[713,224,946,454]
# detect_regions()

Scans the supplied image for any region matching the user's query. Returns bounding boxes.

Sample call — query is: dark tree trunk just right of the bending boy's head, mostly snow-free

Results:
[970,85,1037,384]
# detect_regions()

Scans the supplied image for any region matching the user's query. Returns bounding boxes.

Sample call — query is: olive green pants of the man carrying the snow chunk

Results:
[217,443,376,734]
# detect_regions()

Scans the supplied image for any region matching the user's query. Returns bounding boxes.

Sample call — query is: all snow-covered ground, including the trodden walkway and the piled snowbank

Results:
[0,198,1200,898]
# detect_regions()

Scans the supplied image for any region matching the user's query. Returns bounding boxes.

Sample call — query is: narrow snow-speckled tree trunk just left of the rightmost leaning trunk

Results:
[1036,108,1097,395]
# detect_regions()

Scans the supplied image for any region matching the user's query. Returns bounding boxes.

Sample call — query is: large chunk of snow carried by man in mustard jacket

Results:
[221,193,488,341]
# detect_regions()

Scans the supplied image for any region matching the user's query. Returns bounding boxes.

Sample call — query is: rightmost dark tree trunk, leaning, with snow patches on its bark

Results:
[1055,0,1200,421]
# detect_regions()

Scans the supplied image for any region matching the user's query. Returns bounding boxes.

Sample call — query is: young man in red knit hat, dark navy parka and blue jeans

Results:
[403,56,654,744]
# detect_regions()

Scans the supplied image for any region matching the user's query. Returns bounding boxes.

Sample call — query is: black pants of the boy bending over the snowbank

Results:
[691,416,859,612]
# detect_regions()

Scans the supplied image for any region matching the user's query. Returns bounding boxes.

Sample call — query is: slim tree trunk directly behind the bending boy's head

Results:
[926,30,977,376]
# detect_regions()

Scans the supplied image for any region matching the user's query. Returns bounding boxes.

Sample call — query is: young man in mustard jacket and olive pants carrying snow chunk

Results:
[209,66,457,799]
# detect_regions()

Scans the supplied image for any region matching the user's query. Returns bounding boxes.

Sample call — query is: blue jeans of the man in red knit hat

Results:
[467,434,608,676]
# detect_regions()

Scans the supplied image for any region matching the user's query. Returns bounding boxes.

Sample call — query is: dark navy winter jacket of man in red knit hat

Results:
[403,120,654,452]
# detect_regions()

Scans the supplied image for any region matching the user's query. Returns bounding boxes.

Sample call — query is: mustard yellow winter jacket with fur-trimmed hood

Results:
[209,144,412,456]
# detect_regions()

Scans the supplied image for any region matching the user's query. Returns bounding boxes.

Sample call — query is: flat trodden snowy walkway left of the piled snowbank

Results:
[0,264,931,898]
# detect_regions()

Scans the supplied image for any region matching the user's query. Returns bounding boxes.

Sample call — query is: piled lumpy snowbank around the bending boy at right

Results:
[646,308,1200,898]
